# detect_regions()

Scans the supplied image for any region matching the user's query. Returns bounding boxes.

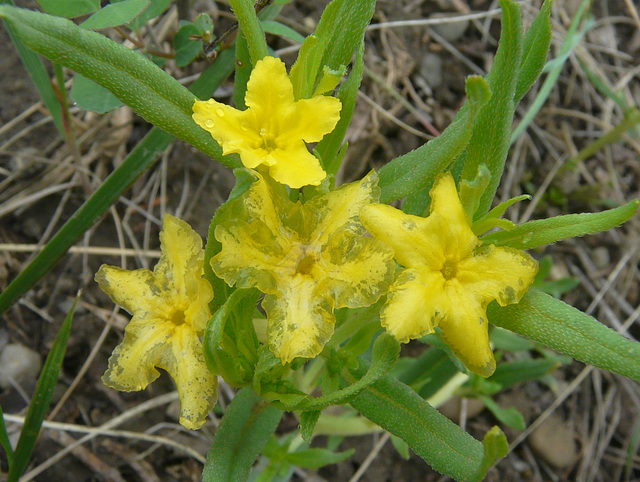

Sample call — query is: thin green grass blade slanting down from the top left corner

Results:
[0,0,65,137]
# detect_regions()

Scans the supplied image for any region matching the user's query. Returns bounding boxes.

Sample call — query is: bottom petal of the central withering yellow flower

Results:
[262,275,335,365]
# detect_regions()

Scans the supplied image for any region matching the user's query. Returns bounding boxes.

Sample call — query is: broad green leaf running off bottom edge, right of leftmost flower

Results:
[202,388,282,482]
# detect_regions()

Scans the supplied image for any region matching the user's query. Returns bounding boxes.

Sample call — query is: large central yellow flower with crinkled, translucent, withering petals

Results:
[211,172,395,364]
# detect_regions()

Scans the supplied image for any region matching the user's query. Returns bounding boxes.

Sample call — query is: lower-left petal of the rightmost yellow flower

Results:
[380,269,446,343]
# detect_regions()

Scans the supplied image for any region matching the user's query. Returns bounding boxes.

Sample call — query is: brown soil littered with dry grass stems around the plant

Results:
[0,0,640,482]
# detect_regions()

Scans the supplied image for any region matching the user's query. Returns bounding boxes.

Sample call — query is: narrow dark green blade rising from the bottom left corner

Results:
[7,298,78,482]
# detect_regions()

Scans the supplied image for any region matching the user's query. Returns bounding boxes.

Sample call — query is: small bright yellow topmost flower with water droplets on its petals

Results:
[193,57,341,188]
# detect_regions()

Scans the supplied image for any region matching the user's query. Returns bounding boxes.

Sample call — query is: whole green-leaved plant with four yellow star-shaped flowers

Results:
[0,0,640,481]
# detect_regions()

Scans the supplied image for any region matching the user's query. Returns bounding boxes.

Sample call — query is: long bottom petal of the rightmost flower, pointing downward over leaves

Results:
[440,280,496,377]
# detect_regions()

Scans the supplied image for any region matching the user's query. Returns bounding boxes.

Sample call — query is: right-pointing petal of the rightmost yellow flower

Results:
[456,246,538,306]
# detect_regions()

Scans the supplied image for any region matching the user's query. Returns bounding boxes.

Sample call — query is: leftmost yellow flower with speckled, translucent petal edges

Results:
[96,215,218,429]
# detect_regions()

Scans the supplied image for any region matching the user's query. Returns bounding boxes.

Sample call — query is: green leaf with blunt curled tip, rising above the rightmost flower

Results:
[378,75,491,203]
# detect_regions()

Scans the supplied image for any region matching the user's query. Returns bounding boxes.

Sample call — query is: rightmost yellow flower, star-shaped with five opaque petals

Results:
[360,173,538,377]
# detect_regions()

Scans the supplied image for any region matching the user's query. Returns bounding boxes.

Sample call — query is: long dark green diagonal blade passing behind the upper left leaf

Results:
[0,51,234,313]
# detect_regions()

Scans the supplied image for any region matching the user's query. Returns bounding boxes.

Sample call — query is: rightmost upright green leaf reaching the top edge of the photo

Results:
[514,0,553,104]
